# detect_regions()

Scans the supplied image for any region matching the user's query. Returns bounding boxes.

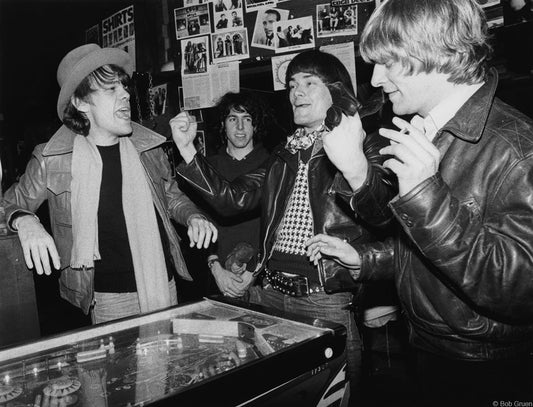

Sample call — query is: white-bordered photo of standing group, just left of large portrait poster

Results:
[211,28,250,63]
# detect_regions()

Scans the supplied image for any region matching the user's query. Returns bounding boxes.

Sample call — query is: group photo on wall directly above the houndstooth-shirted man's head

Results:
[316,3,358,38]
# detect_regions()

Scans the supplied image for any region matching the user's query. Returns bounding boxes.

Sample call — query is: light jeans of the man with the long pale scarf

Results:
[91,279,178,324]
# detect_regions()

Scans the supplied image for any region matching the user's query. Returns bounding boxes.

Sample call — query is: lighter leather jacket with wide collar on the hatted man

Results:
[4,122,199,313]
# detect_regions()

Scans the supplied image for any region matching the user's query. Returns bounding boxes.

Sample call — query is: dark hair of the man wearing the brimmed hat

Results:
[63,65,130,136]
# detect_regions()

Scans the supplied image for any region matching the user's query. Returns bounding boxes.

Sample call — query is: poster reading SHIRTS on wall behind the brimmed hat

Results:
[102,5,135,70]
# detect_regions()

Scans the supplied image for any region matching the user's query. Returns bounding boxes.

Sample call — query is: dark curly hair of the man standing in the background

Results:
[216,91,273,144]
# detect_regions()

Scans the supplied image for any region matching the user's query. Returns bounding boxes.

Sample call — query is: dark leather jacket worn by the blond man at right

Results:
[356,70,533,360]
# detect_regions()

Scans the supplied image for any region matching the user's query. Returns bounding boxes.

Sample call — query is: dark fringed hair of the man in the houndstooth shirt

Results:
[285,50,355,95]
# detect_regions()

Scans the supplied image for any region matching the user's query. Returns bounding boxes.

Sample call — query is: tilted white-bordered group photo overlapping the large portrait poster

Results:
[274,16,315,52]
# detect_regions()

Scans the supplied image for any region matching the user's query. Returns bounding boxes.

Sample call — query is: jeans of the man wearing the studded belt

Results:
[249,285,362,395]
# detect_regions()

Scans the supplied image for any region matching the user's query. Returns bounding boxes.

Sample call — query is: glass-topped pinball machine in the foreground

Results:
[0,299,349,407]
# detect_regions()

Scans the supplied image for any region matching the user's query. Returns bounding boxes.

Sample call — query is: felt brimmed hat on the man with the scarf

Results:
[57,44,133,120]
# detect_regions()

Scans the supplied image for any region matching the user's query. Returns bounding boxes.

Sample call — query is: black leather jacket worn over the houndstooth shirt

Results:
[178,124,395,284]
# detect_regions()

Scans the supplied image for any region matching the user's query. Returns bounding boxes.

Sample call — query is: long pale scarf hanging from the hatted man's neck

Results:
[70,135,170,313]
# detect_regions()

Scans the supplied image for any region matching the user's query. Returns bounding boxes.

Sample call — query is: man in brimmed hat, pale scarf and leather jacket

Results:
[4,44,217,323]
